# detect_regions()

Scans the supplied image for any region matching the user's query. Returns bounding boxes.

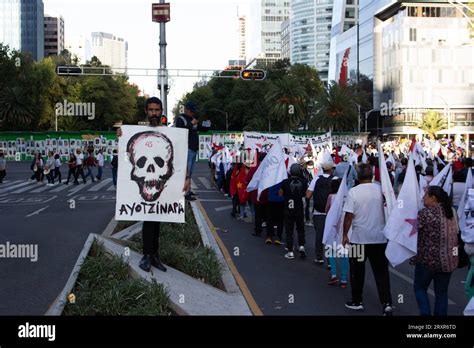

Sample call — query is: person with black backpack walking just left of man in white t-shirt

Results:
[306,161,338,265]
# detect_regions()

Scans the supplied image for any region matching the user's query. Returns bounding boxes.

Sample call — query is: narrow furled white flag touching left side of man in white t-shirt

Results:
[323,169,349,246]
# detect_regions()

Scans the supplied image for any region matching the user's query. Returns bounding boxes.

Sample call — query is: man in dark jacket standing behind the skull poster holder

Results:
[175,101,209,201]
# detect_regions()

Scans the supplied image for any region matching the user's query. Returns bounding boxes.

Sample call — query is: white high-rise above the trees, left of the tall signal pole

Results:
[92,32,128,74]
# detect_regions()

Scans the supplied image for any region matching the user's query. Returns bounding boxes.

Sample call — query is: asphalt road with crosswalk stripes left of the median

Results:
[0,162,115,315]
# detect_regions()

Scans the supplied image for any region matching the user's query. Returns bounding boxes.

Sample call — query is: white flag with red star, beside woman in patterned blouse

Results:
[384,158,421,267]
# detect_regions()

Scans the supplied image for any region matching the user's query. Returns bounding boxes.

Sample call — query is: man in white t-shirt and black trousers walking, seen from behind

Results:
[342,164,392,315]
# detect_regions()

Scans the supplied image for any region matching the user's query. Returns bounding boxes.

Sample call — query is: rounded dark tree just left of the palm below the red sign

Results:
[265,76,307,131]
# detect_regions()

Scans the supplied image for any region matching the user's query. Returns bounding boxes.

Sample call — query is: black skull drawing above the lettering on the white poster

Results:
[127,131,174,202]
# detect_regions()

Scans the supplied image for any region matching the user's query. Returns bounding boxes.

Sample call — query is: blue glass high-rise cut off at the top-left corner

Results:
[0,0,44,60]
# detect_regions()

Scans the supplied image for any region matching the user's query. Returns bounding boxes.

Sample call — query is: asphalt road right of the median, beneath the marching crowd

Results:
[193,163,467,315]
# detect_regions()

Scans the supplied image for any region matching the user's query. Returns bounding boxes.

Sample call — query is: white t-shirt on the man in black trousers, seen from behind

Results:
[344,183,387,244]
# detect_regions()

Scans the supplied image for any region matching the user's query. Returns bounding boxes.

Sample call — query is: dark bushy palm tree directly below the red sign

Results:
[311,81,358,131]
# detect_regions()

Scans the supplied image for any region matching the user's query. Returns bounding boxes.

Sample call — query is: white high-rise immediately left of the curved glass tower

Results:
[247,0,290,65]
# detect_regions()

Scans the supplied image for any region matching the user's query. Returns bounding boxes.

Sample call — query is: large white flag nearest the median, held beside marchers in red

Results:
[247,142,288,200]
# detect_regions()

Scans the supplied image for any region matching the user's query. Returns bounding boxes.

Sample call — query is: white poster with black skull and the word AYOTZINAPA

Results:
[115,126,188,223]
